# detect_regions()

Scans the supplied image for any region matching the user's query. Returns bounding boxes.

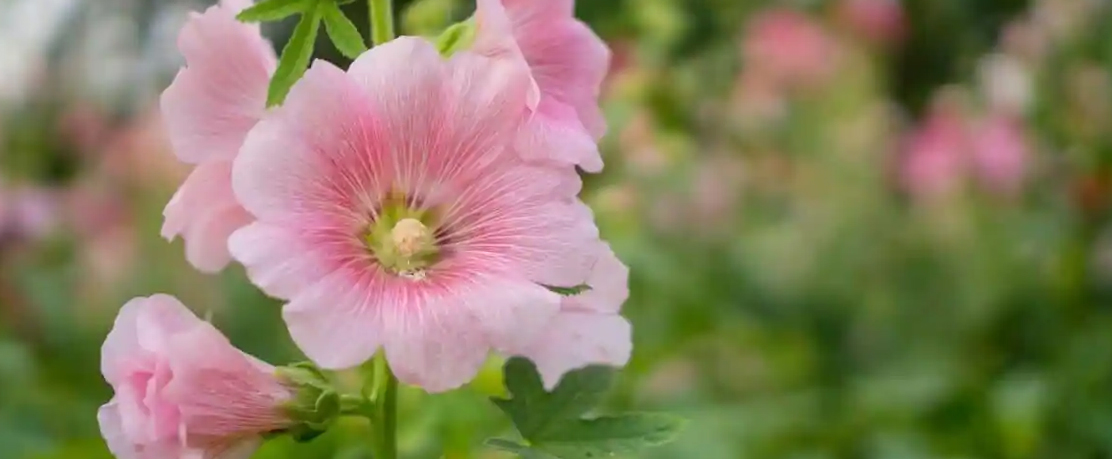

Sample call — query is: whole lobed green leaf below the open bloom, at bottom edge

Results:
[487,358,684,459]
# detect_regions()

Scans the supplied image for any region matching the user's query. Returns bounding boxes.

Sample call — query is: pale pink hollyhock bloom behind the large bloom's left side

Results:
[161,0,277,272]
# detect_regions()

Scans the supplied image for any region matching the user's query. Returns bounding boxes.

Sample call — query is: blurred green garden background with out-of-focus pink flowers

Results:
[0,0,1112,459]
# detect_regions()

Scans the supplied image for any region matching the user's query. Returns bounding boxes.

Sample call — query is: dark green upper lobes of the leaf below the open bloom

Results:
[492,357,614,440]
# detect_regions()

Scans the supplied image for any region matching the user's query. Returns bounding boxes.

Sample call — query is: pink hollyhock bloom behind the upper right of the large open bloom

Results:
[471,0,610,172]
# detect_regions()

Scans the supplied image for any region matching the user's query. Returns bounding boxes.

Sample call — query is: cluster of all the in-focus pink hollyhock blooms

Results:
[100,0,632,458]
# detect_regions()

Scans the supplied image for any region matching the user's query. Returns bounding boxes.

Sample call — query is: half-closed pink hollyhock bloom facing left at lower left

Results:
[97,295,294,459]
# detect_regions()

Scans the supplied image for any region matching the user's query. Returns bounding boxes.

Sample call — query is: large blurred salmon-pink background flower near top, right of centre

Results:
[742,8,837,87]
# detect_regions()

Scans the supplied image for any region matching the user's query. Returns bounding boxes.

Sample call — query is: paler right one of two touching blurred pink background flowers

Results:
[971,114,1031,196]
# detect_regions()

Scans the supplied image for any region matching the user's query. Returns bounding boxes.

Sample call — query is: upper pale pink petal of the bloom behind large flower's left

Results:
[161,0,277,162]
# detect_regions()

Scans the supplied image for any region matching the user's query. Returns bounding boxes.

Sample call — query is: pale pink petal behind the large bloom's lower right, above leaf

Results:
[524,312,633,389]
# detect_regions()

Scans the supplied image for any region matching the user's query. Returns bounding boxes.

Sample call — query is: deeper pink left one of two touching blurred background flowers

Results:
[901,102,969,198]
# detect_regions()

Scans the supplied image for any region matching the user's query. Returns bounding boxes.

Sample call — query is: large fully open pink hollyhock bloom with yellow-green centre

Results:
[229,37,598,391]
